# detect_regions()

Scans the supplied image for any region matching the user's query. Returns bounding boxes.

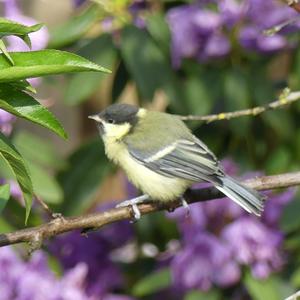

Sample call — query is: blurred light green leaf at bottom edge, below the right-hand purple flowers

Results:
[244,273,282,300]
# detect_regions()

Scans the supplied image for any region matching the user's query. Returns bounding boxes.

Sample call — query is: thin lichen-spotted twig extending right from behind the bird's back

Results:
[178,89,300,123]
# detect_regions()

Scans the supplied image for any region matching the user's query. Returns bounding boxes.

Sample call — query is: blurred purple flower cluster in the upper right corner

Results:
[167,0,297,67]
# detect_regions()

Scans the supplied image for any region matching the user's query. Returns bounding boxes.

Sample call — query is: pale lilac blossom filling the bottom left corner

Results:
[0,247,92,300]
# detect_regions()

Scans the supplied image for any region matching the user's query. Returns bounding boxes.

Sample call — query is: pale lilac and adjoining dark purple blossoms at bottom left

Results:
[0,209,133,300]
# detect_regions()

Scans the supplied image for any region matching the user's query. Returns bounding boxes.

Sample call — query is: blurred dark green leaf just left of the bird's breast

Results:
[58,137,111,215]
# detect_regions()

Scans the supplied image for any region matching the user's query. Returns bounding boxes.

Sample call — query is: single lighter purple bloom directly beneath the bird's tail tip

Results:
[221,216,284,278]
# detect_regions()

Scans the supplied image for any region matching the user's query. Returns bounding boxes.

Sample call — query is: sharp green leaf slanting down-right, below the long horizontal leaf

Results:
[0,84,67,138]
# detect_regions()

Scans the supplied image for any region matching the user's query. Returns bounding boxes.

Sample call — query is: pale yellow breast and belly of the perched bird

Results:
[103,137,190,201]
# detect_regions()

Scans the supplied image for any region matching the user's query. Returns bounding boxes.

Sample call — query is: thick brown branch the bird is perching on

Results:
[0,172,300,250]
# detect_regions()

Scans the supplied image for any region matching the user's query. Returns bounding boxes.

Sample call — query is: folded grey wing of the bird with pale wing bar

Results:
[129,137,224,184]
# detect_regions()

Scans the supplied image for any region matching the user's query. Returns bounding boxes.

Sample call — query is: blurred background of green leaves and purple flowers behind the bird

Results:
[0,0,300,300]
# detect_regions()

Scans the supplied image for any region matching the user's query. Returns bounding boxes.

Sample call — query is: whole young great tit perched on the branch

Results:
[89,104,263,218]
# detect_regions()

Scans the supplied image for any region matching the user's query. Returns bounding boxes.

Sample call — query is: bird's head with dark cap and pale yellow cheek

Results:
[89,104,142,139]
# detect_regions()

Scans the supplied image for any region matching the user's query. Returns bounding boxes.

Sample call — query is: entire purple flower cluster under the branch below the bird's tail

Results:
[170,162,295,291]
